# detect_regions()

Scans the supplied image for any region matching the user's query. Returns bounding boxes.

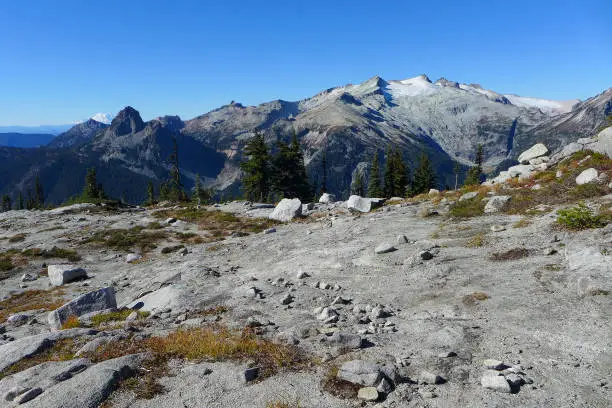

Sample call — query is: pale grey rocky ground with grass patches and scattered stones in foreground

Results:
[0,151,612,408]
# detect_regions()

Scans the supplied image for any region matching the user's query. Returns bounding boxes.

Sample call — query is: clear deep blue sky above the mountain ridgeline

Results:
[0,0,612,125]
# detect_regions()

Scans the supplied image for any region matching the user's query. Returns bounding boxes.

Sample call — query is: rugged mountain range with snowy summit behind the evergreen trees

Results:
[0,75,612,203]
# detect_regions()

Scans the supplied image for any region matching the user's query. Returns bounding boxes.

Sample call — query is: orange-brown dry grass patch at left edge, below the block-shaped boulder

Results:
[0,288,65,323]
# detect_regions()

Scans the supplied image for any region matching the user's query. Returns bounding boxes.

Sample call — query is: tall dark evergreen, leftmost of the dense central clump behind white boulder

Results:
[240,133,271,202]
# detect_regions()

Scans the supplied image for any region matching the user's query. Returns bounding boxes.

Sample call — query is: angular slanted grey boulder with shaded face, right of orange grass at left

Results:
[47,287,117,329]
